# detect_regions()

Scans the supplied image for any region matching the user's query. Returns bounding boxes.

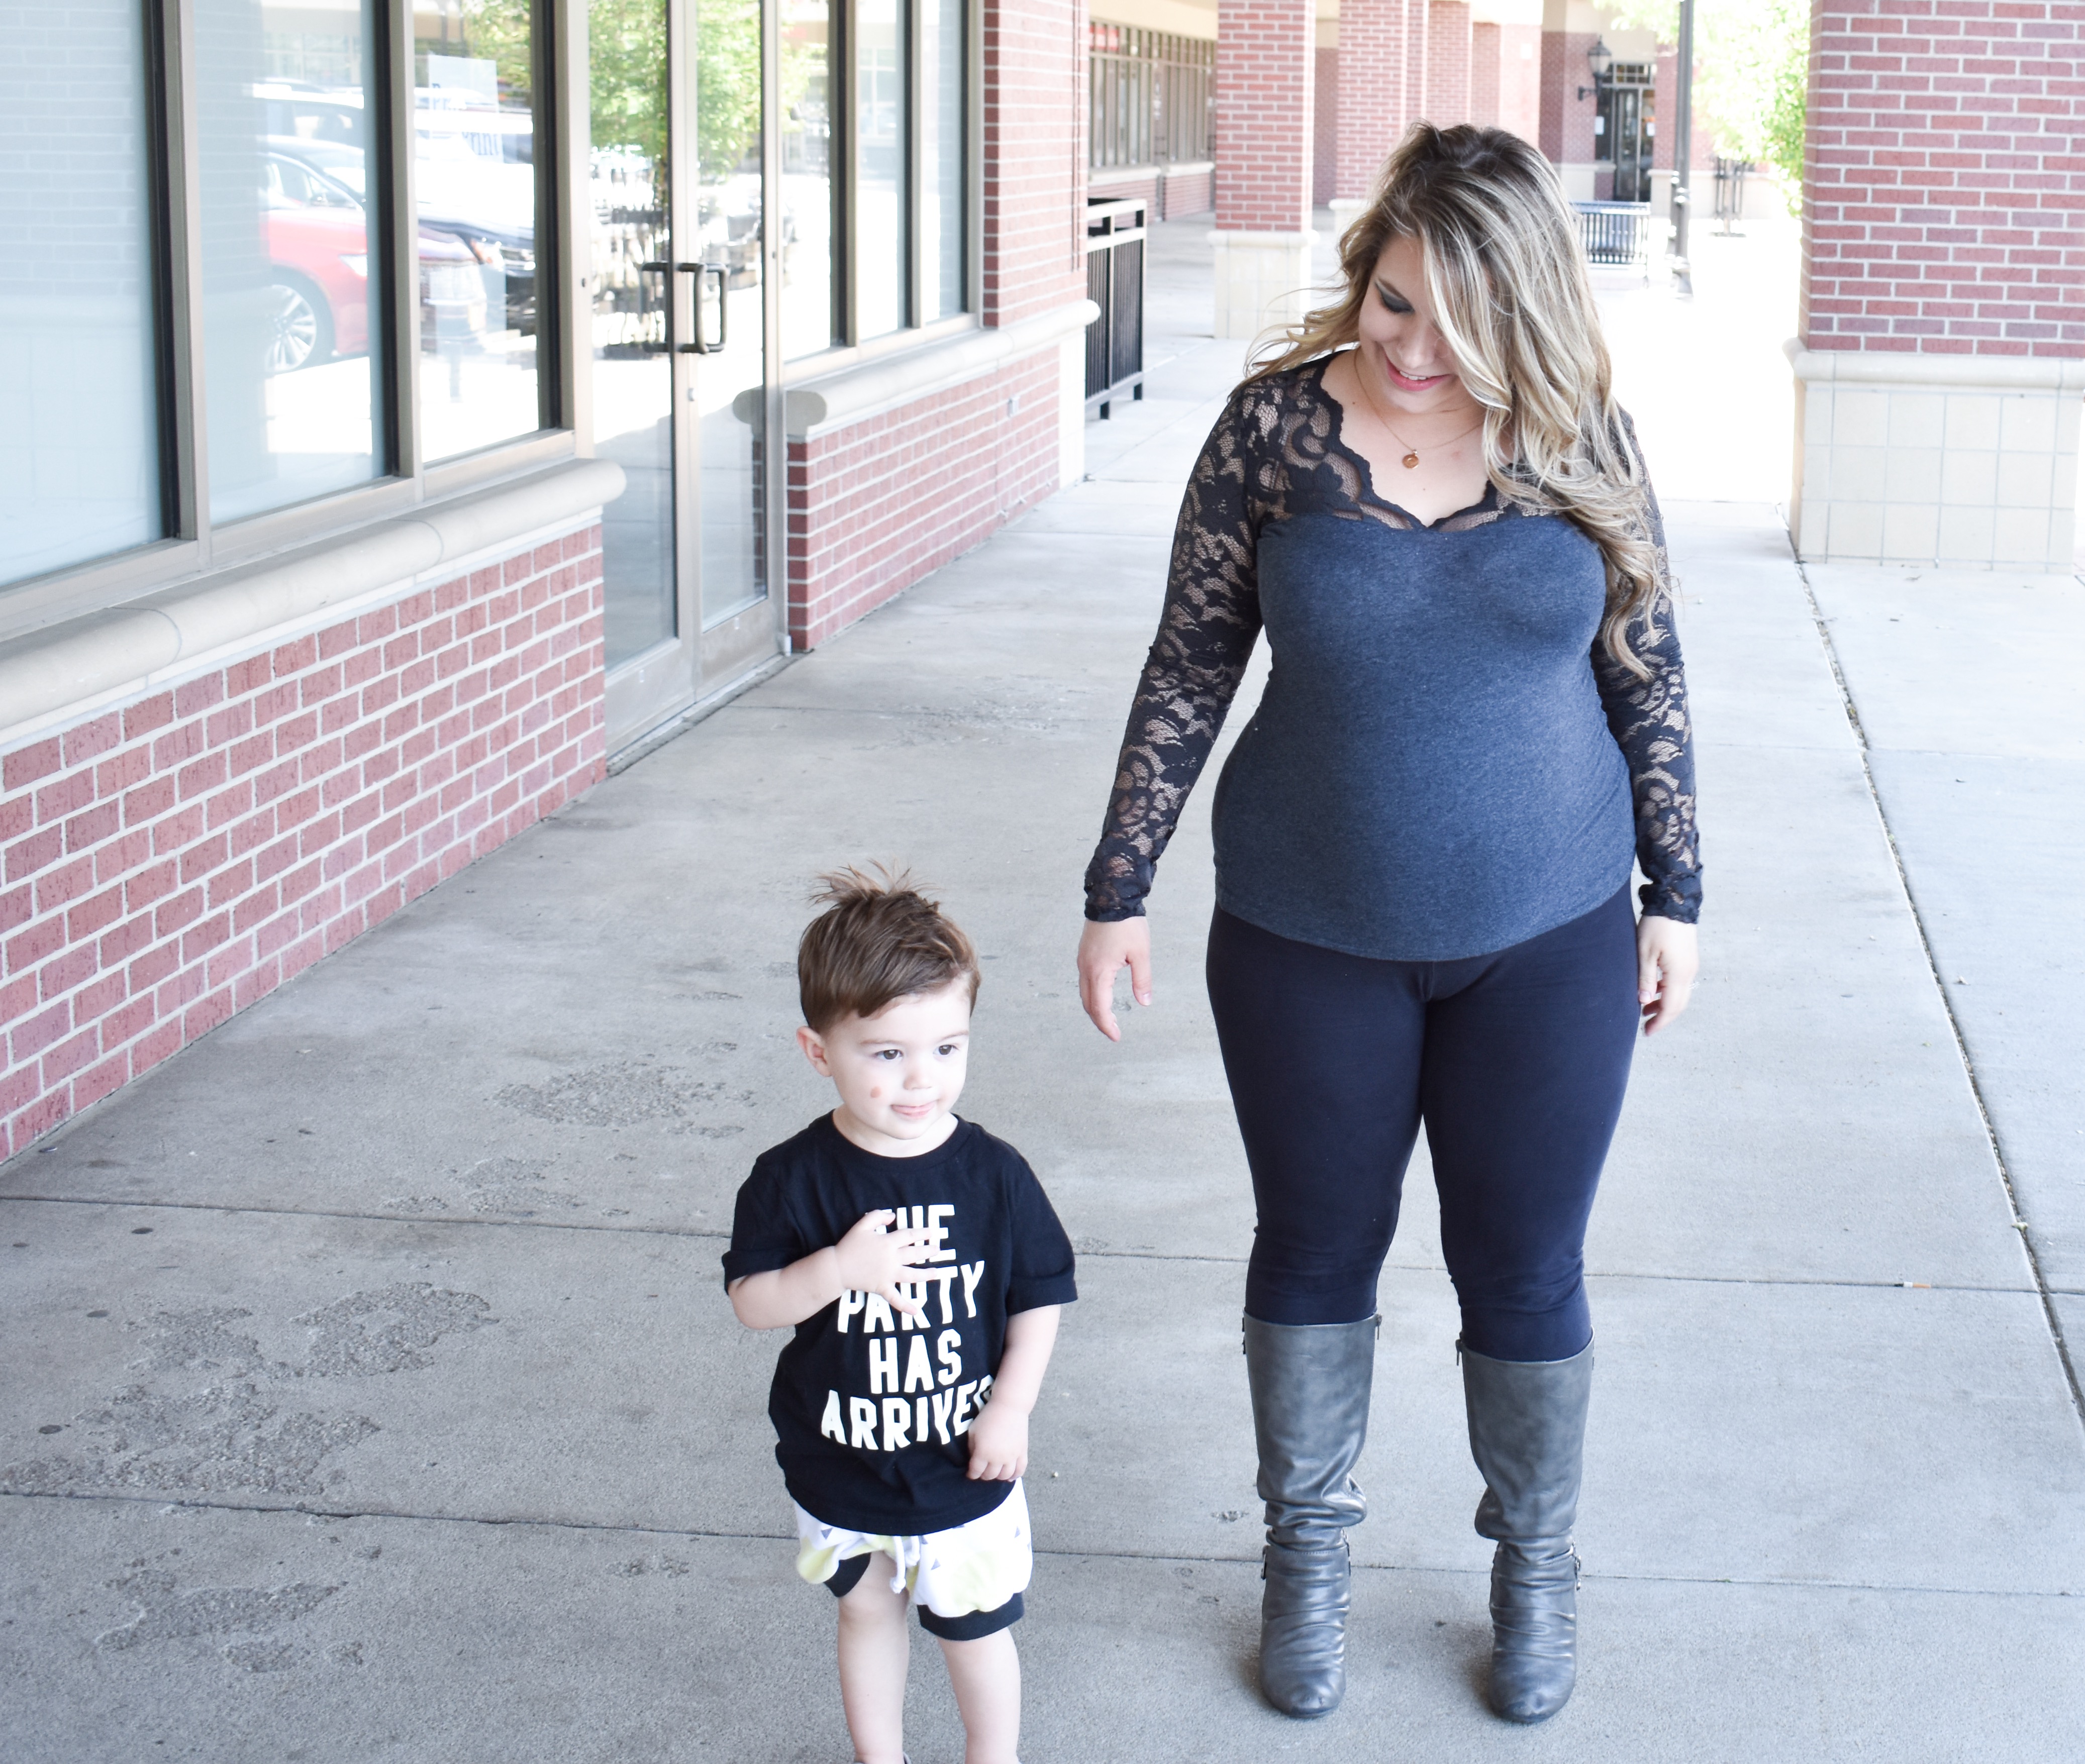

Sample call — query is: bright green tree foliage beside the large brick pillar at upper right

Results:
[1608,0,1810,209]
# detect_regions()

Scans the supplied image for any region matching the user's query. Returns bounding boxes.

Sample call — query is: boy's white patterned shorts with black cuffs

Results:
[797,1483,1034,1641]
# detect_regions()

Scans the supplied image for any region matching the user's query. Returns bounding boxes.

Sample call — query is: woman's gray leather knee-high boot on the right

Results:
[1461,1347,1593,1722]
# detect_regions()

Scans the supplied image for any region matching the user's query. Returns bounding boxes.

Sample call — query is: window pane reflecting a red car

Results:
[194,0,383,522]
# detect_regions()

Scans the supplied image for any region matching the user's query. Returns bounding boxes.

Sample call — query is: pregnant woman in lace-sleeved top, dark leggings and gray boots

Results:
[1078,123,1702,1722]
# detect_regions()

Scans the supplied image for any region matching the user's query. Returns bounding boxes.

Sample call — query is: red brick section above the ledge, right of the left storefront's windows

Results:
[982,0,1086,325]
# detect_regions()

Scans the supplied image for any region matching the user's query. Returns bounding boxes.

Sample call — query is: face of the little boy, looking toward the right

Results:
[797,976,969,1157]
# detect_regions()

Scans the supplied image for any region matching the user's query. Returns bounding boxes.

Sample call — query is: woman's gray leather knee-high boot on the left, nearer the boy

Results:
[1245,1318,1376,1718]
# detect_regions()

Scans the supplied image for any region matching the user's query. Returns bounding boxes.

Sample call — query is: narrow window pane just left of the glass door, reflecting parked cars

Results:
[413,0,544,461]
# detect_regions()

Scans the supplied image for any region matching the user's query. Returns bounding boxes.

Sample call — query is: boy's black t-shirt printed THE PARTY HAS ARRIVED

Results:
[724,1115,1078,1537]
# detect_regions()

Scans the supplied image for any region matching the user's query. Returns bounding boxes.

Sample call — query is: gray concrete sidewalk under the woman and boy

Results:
[12,223,2085,1764]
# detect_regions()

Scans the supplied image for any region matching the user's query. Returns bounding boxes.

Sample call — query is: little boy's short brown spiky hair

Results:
[797,863,978,1034]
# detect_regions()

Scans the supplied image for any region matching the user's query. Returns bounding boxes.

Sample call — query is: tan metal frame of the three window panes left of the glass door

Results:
[0,0,590,640]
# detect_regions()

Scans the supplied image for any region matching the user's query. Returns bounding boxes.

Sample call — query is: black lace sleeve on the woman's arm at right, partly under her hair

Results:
[1593,417,1702,926]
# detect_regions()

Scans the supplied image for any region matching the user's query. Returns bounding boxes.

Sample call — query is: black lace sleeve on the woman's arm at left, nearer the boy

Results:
[1086,388,1274,921]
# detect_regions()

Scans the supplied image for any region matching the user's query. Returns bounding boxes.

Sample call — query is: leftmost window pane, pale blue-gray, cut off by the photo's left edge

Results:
[0,0,160,582]
